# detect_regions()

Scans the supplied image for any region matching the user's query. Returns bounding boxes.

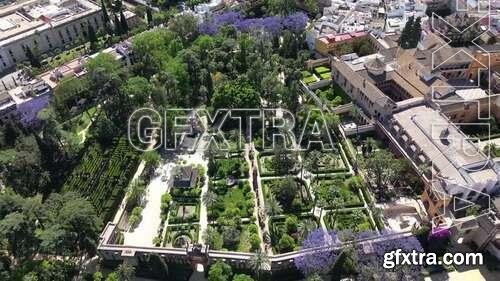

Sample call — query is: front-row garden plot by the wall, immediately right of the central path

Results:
[269,215,319,254]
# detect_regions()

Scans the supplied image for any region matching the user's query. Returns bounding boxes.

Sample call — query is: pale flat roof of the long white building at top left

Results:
[0,0,101,45]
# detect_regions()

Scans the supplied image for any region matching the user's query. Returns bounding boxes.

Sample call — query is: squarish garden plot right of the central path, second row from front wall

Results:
[262,177,313,215]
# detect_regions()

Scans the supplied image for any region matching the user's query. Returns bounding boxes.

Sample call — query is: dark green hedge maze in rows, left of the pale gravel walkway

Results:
[63,138,139,221]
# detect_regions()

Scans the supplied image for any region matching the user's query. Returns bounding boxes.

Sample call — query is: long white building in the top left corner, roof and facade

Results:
[0,0,103,72]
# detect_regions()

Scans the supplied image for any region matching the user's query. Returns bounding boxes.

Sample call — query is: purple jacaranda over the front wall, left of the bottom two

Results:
[294,228,339,276]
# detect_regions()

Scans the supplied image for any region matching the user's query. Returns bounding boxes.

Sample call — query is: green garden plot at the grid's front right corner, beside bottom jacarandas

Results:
[323,209,375,232]
